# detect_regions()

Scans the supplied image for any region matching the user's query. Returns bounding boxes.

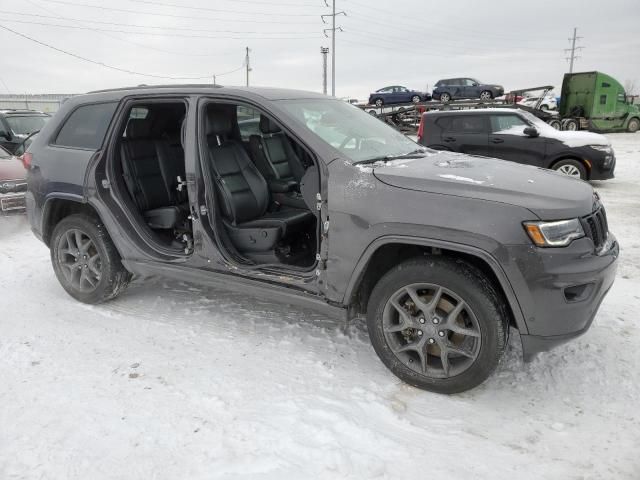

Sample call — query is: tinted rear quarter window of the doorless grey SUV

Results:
[54,102,118,150]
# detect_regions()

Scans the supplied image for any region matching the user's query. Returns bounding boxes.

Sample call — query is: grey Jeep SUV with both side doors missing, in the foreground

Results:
[24,85,619,393]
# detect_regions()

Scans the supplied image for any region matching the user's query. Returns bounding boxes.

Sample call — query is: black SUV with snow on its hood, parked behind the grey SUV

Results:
[418,108,616,180]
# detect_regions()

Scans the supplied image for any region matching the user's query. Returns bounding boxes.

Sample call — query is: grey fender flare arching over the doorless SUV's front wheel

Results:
[344,235,529,335]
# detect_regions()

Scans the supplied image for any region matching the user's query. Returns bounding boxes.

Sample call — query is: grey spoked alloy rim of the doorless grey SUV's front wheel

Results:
[382,283,481,378]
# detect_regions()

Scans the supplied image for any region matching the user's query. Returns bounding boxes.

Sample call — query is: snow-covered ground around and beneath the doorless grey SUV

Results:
[0,134,640,480]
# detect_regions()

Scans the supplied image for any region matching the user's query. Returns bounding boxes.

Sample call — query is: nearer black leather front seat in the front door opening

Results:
[206,107,315,253]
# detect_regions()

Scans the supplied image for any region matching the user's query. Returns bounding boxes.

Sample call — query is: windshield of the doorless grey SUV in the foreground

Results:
[279,99,422,163]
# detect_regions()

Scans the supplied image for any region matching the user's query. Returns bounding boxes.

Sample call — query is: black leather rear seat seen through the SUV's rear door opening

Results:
[121,119,188,229]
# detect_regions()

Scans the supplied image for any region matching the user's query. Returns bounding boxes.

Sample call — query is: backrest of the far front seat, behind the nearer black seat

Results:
[249,115,305,192]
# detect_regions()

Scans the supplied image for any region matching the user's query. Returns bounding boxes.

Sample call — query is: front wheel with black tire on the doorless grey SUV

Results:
[367,257,508,394]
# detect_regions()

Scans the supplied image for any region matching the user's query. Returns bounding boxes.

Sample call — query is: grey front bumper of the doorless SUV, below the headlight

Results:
[509,233,620,360]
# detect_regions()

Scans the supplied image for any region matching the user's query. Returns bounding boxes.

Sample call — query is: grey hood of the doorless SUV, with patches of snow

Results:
[373,151,594,220]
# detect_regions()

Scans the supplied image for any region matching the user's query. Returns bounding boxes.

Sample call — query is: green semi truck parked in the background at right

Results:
[549,72,640,132]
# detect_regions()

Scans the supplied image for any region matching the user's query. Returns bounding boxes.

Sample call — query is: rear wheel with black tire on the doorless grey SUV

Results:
[50,214,131,304]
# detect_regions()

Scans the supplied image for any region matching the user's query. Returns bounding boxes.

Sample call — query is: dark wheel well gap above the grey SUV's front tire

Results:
[349,243,516,327]
